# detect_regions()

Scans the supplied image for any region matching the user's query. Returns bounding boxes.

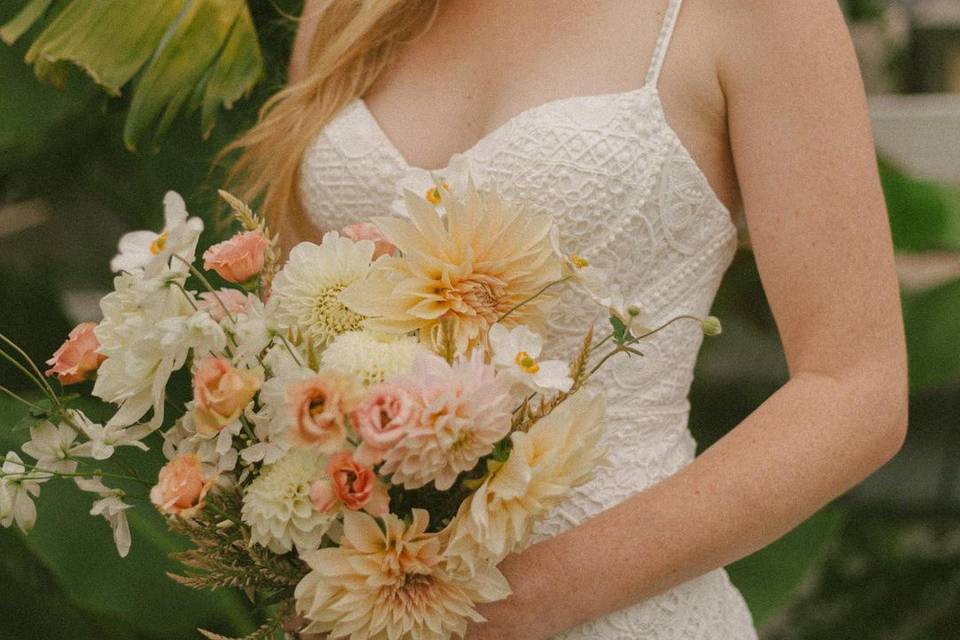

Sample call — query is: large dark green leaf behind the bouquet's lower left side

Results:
[0,400,255,640]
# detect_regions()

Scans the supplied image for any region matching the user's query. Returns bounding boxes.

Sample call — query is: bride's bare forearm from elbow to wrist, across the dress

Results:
[503,363,907,638]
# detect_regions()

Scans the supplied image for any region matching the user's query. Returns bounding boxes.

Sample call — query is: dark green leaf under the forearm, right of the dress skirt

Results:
[728,507,845,625]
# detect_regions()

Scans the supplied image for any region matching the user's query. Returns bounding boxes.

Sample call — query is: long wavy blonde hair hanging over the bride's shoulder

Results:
[218,0,440,240]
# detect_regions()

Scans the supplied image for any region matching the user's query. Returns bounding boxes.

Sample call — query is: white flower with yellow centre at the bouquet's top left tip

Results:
[110,191,203,278]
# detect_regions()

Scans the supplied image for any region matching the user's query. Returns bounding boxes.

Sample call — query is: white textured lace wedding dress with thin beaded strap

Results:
[300,0,756,640]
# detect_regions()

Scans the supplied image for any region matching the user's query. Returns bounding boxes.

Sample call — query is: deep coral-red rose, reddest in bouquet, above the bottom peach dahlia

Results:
[310,451,390,516]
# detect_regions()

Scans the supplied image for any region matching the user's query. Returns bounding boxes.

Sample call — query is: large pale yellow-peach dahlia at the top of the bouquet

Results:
[340,175,561,353]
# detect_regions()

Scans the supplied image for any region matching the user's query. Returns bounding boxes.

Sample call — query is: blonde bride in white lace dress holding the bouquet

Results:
[223,0,907,640]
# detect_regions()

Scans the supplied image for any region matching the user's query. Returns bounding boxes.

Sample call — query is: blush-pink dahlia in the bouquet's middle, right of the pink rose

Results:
[380,349,511,491]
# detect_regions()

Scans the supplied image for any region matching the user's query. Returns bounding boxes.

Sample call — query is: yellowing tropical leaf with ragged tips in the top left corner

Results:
[0,0,263,149]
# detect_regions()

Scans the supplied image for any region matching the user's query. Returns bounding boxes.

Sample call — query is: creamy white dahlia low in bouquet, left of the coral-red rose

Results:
[241,447,336,553]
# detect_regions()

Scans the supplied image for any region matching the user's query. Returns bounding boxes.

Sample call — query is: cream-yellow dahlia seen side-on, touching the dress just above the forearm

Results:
[445,390,605,570]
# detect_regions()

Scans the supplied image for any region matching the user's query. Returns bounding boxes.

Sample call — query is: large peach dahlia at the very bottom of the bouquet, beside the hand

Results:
[295,509,510,640]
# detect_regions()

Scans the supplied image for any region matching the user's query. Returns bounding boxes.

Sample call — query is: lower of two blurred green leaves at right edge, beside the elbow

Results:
[903,281,960,392]
